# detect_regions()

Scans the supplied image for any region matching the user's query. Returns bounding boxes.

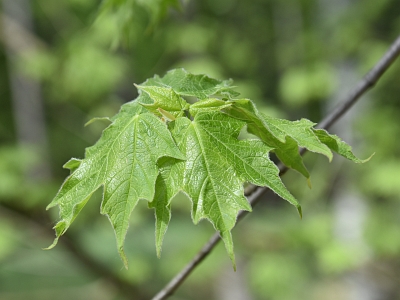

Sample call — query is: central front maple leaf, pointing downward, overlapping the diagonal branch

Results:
[166,112,301,262]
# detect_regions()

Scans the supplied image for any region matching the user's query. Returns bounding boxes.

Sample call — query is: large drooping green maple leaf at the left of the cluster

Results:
[48,102,184,266]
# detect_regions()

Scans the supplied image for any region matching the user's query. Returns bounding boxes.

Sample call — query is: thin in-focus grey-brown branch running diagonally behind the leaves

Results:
[153,36,400,300]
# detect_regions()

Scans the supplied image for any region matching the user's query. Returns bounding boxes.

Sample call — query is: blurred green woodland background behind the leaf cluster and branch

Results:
[0,0,400,300]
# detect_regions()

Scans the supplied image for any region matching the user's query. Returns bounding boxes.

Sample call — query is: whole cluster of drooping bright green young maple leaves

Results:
[48,69,364,267]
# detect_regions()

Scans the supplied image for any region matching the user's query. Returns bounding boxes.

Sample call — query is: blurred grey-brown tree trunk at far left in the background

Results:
[1,0,50,179]
